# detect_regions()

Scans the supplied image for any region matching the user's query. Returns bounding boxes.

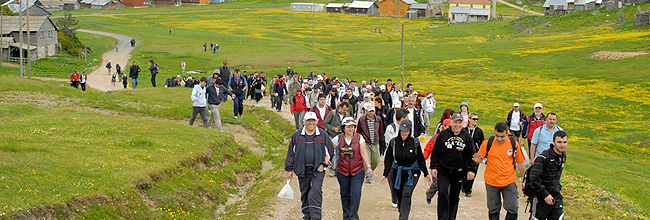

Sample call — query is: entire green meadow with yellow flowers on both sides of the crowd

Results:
[0,3,650,219]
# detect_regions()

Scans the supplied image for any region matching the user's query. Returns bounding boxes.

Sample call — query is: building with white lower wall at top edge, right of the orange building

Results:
[449,0,488,23]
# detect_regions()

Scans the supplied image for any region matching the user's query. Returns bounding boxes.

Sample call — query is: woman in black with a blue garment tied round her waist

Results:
[380,119,431,220]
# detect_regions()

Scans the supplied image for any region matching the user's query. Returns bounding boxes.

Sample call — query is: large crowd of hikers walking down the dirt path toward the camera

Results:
[280,68,568,219]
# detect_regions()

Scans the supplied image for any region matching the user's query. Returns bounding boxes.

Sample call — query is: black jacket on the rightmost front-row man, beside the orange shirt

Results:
[529,148,566,199]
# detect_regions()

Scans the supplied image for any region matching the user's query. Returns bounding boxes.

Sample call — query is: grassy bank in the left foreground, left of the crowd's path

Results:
[0,76,292,219]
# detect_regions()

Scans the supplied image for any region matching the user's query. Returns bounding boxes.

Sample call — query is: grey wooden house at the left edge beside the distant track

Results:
[0,16,59,61]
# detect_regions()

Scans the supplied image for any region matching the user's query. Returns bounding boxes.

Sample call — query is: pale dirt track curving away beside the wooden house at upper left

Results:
[77,29,135,92]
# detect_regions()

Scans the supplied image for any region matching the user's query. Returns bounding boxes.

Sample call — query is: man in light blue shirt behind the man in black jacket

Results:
[530,112,562,160]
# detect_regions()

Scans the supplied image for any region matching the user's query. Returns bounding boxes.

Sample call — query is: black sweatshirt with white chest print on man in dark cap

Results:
[429,127,477,174]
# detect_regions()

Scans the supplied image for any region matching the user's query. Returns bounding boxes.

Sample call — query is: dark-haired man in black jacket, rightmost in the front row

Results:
[527,131,569,220]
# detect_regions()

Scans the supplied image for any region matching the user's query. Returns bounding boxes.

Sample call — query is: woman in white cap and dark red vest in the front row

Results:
[330,116,374,219]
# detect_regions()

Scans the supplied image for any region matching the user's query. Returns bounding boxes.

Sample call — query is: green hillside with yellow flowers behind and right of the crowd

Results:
[64,5,650,217]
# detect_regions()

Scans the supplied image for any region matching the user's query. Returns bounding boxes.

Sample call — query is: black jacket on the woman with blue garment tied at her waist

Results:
[383,135,429,177]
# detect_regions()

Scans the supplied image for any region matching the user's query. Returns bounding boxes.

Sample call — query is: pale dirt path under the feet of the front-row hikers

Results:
[245,97,529,220]
